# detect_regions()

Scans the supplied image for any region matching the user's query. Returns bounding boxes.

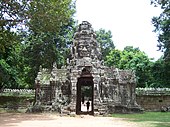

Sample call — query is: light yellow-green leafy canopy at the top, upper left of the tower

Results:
[28,0,75,33]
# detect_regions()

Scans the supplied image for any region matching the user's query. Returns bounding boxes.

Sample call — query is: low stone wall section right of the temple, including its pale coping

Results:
[136,88,170,111]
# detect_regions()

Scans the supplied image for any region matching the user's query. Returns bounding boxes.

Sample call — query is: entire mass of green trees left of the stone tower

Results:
[0,0,75,88]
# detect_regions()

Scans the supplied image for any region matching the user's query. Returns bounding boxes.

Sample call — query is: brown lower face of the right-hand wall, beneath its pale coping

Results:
[136,95,170,111]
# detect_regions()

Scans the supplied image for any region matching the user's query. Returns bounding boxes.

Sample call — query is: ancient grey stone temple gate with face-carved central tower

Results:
[35,21,140,115]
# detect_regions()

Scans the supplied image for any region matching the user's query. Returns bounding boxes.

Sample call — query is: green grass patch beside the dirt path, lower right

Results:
[112,112,170,127]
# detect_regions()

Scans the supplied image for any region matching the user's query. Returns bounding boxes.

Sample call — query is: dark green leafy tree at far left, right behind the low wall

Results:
[0,35,24,88]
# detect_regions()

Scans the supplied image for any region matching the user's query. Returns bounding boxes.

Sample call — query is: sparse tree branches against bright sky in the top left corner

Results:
[0,0,30,53]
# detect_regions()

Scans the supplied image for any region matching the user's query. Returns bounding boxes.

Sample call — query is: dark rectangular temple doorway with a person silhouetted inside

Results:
[76,77,94,115]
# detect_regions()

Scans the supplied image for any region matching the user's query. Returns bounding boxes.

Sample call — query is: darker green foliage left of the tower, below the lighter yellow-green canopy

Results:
[23,20,75,88]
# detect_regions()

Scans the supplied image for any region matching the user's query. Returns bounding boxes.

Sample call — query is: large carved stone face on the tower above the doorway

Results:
[78,41,90,57]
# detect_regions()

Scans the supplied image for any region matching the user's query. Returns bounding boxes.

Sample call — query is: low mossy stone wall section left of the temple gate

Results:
[0,89,35,110]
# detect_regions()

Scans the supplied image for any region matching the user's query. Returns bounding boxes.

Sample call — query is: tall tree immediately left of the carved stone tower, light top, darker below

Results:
[22,0,75,87]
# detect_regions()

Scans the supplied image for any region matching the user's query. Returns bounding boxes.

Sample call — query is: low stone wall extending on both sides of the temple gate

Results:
[0,88,170,111]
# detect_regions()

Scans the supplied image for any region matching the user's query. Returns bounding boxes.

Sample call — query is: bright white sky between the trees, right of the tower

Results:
[75,0,163,60]
